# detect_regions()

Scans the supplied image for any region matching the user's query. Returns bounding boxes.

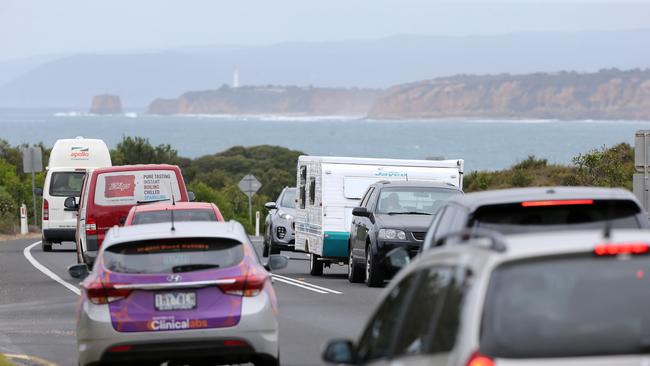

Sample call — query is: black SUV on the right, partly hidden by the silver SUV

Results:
[423,187,650,249]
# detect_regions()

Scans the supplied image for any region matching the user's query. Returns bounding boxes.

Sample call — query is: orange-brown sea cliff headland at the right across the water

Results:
[368,69,650,120]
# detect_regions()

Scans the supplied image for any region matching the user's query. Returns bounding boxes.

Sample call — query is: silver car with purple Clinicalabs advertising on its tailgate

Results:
[69,221,287,365]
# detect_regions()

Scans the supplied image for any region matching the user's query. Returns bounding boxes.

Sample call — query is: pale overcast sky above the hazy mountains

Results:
[0,0,650,60]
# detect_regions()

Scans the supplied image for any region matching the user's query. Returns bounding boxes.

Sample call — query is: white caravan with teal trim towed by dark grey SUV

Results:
[295,156,464,276]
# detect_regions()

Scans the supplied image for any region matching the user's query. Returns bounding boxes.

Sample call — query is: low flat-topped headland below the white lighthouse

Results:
[148,86,380,115]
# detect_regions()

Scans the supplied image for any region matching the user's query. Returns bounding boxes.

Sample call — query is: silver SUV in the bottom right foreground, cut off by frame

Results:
[323,230,650,366]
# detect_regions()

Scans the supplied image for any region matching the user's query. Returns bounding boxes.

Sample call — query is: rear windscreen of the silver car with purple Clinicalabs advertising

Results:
[103,238,244,274]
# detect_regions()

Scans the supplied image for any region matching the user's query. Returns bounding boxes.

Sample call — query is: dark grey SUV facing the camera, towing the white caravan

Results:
[348,181,463,287]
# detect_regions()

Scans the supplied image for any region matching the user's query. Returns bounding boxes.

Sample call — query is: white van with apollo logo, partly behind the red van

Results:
[41,137,111,252]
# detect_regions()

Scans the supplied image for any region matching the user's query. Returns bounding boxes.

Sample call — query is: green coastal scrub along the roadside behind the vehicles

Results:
[0,137,634,234]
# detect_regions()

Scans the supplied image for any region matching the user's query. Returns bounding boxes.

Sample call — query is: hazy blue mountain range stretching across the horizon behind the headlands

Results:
[0,29,650,110]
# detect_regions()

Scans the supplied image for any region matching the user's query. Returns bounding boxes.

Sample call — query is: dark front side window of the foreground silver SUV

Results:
[358,273,416,361]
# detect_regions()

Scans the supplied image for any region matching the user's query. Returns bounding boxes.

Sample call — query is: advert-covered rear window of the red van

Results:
[95,170,181,206]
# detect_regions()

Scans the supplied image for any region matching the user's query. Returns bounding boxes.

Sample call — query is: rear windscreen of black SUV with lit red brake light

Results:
[472,200,642,234]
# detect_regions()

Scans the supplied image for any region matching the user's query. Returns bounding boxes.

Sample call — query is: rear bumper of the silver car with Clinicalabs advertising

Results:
[77,291,278,365]
